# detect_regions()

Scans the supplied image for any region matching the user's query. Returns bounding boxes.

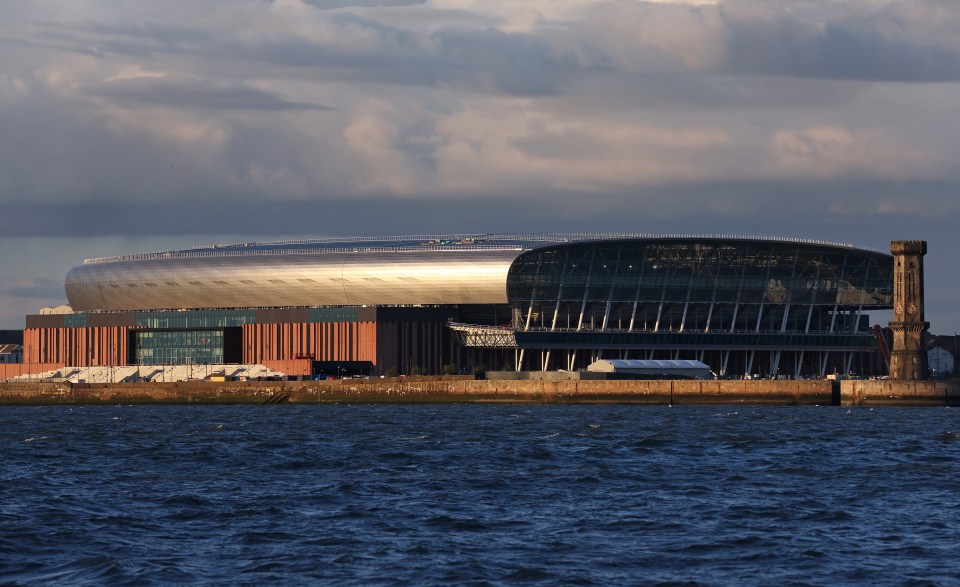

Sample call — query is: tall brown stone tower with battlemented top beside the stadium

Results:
[890,241,930,381]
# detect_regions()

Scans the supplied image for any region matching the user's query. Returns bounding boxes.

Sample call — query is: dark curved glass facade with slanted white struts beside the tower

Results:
[507,238,893,373]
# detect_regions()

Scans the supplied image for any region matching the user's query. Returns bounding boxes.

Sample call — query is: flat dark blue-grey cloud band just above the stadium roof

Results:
[0,181,960,241]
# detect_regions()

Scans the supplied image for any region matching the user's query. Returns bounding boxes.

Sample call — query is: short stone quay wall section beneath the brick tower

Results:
[840,380,960,406]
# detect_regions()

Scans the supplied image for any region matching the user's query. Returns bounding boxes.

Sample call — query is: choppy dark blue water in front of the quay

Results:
[0,405,960,585]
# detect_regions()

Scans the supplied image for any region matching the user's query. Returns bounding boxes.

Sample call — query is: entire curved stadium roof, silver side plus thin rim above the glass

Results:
[65,233,892,311]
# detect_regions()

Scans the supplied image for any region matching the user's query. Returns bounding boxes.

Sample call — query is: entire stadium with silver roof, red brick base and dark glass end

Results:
[24,234,893,377]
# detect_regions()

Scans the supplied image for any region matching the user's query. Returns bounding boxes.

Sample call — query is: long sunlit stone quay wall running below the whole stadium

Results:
[0,377,836,405]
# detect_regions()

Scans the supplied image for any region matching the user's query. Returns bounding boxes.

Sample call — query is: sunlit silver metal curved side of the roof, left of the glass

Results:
[66,249,522,310]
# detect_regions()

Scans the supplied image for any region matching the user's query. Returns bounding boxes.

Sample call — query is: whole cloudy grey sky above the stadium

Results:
[0,0,960,333]
